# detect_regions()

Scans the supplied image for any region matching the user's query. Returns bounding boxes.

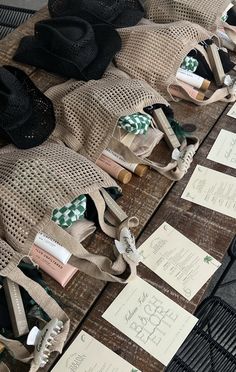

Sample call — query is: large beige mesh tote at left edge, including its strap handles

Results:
[0,141,138,283]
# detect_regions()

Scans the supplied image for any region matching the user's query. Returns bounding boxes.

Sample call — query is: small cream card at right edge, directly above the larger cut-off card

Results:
[207,129,236,169]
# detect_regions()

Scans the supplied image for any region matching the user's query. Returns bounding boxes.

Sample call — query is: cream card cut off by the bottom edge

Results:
[52,331,140,372]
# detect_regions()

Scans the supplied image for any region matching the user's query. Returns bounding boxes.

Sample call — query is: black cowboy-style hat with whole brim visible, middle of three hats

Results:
[14,17,121,81]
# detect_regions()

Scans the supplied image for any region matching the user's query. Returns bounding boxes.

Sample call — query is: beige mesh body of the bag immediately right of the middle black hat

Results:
[115,21,213,100]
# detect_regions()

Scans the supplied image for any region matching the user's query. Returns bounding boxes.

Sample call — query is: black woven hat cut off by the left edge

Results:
[0,66,55,149]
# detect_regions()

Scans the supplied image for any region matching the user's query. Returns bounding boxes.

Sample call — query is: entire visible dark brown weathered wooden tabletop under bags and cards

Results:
[0,9,236,372]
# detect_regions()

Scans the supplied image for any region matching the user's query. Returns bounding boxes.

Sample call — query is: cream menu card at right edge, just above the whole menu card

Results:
[182,165,236,218]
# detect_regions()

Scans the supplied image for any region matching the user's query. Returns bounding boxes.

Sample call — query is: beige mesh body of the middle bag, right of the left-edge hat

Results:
[46,70,168,161]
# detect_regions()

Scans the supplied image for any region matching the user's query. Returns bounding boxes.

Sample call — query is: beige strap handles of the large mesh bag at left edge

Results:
[43,189,138,283]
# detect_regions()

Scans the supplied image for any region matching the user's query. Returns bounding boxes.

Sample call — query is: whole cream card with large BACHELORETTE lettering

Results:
[103,278,197,366]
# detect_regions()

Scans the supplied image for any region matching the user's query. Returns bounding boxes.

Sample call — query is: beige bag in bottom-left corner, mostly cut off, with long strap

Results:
[0,239,70,372]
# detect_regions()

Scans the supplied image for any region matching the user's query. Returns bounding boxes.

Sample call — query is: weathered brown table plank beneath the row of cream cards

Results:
[58,104,236,372]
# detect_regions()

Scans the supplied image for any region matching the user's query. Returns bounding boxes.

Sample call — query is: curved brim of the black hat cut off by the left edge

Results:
[4,66,56,149]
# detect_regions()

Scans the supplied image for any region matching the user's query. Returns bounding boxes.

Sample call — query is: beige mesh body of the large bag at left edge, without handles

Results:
[0,142,117,254]
